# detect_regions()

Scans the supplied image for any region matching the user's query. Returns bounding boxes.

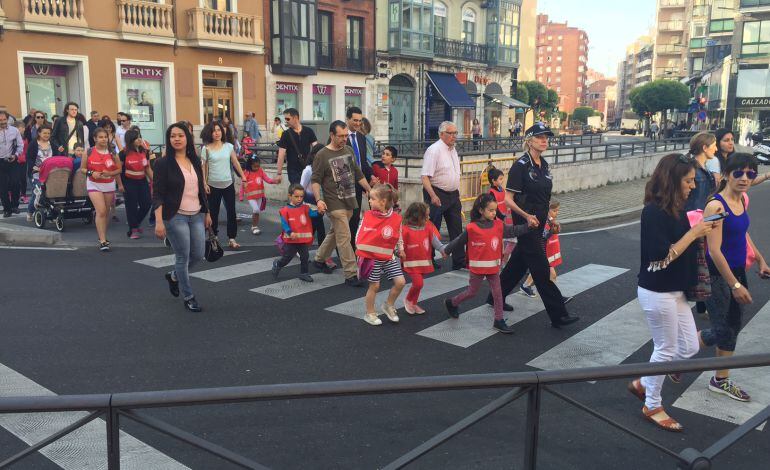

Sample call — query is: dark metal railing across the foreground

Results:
[0,354,770,470]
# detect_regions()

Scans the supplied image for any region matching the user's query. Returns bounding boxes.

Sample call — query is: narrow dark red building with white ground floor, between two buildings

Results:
[264,0,380,138]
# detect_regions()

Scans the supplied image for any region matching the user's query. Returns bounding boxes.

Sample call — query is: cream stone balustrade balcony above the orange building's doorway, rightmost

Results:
[187,8,264,52]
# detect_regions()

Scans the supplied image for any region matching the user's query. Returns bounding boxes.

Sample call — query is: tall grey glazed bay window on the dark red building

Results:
[271,0,317,72]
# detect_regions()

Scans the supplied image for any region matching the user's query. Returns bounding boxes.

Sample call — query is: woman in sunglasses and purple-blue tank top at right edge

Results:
[699,153,770,401]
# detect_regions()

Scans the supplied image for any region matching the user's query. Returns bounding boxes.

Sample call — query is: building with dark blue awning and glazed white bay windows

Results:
[373,0,535,140]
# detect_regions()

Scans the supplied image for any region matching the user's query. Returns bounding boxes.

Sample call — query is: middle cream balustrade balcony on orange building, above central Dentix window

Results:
[117,0,174,38]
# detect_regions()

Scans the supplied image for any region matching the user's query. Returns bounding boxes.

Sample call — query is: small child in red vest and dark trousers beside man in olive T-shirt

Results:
[271,184,318,282]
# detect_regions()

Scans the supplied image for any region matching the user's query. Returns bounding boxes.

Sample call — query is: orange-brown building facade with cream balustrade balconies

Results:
[0,0,265,144]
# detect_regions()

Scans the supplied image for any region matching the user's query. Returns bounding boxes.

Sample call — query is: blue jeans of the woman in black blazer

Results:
[166,213,206,300]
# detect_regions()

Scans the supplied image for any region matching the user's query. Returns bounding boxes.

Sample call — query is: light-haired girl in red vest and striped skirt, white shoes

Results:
[356,184,406,326]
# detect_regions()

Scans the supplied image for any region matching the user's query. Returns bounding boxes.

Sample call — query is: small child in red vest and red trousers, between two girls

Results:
[401,202,443,315]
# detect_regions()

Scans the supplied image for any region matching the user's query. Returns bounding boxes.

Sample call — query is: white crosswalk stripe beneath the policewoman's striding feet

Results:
[417,264,628,348]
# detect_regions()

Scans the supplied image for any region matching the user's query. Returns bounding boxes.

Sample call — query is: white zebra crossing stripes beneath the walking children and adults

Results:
[135,252,770,434]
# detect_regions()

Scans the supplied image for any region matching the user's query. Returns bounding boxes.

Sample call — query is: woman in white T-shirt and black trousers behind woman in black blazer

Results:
[201,121,244,249]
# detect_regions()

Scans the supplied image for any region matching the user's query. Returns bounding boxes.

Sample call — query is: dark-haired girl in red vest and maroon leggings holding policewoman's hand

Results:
[444,193,529,333]
